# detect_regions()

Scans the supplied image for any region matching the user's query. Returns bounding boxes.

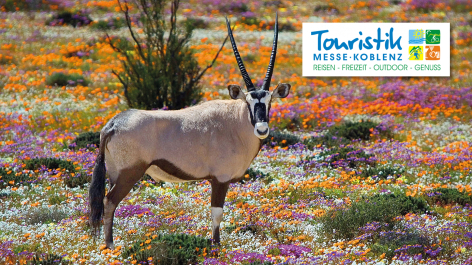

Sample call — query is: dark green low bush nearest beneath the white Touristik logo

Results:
[329,121,378,140]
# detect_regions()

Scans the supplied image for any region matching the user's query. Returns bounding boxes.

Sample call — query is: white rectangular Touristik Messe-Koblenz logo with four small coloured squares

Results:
[302,22,451,77]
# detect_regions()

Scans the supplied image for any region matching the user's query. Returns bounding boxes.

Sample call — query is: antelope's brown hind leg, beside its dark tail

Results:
[103,166,146,249]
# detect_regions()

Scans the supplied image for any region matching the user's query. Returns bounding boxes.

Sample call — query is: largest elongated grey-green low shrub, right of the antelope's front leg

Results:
[321,194,428,239]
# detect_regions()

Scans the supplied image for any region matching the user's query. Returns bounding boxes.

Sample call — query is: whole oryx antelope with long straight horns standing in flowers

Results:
[89,13,290,248]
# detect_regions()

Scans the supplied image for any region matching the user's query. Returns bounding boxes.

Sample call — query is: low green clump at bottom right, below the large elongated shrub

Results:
[371,231,433,259]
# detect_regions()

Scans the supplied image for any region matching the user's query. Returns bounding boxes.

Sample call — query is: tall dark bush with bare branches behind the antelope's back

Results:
[107,0,226,110]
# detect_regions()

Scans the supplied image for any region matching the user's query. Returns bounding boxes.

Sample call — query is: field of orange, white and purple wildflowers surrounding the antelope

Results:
[0,0,472,265]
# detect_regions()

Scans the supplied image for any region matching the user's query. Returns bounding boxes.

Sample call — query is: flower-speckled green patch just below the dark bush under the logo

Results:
[320,146,372,168]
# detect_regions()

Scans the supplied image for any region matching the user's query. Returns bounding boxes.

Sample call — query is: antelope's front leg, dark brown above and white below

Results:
[211,178,229,244]
